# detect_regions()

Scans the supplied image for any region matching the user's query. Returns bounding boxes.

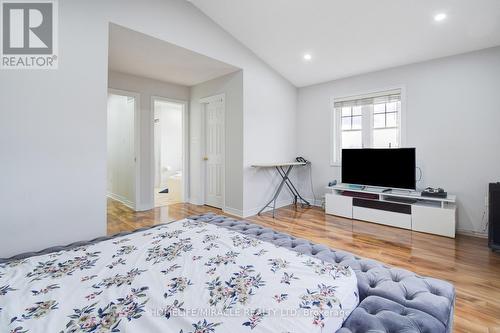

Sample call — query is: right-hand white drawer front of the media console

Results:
[412,206,456,238]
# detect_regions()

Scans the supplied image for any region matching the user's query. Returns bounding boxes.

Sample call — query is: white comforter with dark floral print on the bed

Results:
[0,220,358,333]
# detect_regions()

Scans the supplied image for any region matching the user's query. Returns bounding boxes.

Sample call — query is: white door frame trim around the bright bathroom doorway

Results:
[149,95,189,208]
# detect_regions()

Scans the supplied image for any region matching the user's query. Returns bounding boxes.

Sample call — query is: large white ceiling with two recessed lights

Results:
[188,0,500,87]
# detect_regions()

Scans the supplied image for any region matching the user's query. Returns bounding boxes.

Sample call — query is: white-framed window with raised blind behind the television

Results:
[332,89,401,164]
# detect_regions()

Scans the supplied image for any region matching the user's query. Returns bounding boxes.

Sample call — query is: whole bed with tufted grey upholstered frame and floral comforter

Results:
[0,214,455,333]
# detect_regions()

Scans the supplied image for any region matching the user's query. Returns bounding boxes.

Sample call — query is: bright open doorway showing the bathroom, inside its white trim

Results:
[152,97,187,207]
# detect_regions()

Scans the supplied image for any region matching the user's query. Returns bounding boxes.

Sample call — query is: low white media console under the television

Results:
[325,184,457,238]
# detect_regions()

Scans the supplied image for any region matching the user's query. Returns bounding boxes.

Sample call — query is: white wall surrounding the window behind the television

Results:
[297,48,500,233]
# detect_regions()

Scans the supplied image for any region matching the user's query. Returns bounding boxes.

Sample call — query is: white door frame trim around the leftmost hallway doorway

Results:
[106,88,142,211]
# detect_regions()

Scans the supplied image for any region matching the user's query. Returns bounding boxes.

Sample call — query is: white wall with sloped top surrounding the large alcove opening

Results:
[0,0,296,256]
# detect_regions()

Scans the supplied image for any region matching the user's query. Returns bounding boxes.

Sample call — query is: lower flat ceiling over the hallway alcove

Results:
[108,24,238,86]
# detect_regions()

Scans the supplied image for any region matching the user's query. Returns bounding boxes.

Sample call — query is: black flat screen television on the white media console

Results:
[342,148,416,190]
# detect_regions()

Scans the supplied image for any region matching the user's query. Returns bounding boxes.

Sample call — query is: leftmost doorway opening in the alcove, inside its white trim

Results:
[107,89,139,210]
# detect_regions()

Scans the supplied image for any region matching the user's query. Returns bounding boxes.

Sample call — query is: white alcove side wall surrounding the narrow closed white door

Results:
[189,71,244,215]
